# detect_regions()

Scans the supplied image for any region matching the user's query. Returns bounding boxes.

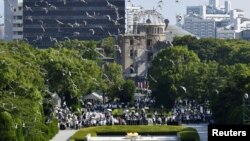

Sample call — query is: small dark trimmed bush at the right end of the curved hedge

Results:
[177,131,200,141]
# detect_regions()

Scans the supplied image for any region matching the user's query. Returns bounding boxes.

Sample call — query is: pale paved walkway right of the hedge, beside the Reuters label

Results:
[184,124,208,141]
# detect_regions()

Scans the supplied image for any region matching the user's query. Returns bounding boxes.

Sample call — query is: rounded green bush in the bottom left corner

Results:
[0,111,16,141]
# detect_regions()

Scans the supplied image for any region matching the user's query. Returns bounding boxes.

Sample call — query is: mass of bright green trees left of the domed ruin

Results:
[0,40,124,141]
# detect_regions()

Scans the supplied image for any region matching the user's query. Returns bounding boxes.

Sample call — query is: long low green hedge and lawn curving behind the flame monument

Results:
[70,125,199,141]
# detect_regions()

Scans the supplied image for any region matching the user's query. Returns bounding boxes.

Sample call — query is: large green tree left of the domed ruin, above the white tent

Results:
[41,48,102,110]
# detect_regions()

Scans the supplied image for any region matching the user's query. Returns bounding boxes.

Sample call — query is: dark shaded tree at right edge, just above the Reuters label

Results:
[211,64,250,124]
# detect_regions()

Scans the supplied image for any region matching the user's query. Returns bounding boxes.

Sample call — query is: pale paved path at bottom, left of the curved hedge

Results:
[50,130,78,141]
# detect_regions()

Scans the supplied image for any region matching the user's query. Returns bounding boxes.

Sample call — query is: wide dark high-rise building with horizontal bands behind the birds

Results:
[23,0,125,48]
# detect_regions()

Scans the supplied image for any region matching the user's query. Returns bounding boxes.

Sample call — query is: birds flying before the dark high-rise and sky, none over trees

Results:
[0,0,182,42]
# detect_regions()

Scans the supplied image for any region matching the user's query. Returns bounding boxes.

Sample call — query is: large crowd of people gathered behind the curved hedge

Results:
[55,99,211,130]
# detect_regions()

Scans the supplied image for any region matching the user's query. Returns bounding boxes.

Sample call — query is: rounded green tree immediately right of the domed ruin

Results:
[149,46,200,108]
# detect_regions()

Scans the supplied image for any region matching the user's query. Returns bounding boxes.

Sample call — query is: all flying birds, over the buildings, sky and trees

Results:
[0,0,187,128]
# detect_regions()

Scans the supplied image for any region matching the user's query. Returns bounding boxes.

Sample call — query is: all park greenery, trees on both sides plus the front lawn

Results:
[0,36,250,141]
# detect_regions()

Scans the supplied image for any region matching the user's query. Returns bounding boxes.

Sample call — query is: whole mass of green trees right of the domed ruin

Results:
[149,36,250,124]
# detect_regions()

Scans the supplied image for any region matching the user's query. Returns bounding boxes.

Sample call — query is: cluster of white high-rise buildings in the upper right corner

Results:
[183,0,250,39]
